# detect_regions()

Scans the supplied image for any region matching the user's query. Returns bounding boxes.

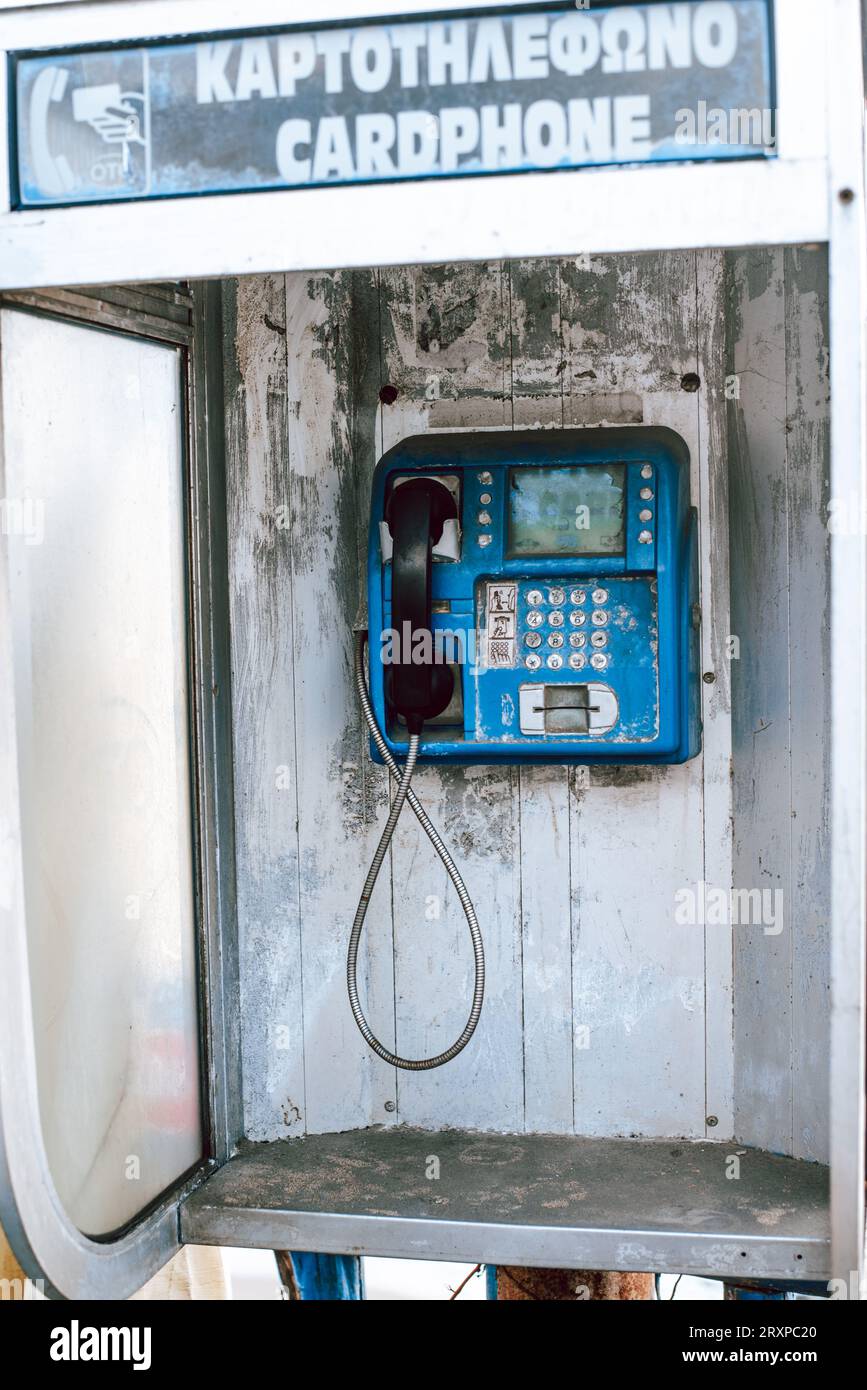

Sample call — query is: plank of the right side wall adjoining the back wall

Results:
[728,249,792,1154]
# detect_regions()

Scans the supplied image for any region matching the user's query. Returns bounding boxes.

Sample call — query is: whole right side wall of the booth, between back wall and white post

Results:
[727,247,833,1162]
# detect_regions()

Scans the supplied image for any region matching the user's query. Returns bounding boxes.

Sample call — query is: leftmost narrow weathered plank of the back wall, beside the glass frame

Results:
[224,275,306,1138]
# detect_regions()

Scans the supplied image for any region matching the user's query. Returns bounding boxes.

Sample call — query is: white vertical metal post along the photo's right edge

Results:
[827,0,867,1289]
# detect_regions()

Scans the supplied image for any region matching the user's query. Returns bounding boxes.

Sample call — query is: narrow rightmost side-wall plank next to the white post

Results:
[784,249,831,1162]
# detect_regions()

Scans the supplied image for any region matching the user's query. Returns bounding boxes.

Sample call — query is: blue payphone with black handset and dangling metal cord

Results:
[347,428,700,1070]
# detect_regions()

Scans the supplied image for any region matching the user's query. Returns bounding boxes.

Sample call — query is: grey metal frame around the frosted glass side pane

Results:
[0,284,242,1298]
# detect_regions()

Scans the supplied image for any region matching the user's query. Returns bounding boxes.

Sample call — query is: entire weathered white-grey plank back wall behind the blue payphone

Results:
[225,253,827,1148]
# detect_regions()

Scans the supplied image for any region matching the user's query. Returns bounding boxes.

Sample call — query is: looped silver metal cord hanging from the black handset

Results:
[346,632,485,1072]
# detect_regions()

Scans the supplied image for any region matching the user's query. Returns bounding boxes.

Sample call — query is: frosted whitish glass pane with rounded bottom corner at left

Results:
[0,310,201,1234]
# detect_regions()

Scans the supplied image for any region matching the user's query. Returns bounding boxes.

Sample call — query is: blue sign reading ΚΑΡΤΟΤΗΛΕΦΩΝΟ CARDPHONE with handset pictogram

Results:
[13,0,774,207]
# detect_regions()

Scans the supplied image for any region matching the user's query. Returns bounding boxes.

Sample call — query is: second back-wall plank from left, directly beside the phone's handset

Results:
[286,271,395,1133]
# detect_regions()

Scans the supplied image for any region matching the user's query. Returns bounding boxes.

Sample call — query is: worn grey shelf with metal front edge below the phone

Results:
[181,1127,829,1280]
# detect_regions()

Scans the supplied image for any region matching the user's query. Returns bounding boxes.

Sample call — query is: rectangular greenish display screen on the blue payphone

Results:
[509,463,627,556]
